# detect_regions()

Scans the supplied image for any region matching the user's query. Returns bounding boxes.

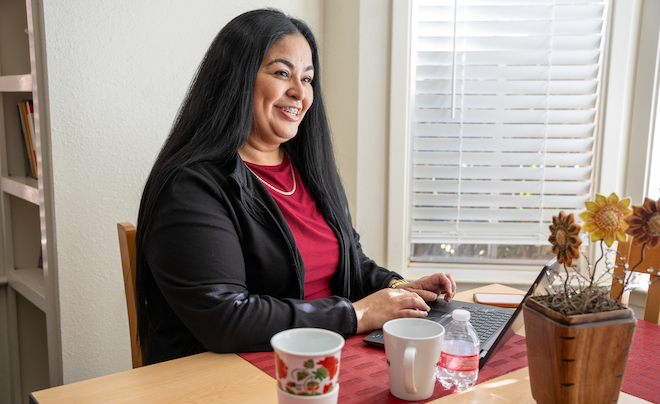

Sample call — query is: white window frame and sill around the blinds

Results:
[387,0,660,284]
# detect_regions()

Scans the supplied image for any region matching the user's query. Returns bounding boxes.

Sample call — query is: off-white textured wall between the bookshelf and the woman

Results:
[44,0,323,383]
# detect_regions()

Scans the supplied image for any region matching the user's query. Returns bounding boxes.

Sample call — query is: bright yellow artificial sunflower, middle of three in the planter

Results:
[580,192,632,247]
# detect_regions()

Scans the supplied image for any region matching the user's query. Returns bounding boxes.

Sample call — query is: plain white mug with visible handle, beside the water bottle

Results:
[383,318,445,401]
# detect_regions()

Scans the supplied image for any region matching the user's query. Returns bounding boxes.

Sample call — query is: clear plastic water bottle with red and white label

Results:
[436,310,479,391]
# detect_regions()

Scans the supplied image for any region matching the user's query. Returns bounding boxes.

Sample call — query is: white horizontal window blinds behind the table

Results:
[411,0,608,245]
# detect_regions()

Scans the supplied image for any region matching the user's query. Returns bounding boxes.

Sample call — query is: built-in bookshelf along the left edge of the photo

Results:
[0,0,62,404]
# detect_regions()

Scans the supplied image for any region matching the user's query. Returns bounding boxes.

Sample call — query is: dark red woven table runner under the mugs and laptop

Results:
[239,320,660,404]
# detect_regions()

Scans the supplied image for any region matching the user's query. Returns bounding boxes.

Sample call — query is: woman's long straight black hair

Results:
[131,9,364,353]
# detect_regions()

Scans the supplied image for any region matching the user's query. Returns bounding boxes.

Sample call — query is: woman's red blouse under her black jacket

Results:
[245,154,339,300]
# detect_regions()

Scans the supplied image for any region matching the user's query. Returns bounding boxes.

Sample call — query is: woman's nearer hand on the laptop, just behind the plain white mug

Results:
[353,288,431,334]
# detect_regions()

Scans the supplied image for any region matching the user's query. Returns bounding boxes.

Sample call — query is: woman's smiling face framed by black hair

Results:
[250,34,314,147]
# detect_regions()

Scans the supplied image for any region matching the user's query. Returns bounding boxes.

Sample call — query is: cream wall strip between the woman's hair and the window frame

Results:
[323,0,392,271]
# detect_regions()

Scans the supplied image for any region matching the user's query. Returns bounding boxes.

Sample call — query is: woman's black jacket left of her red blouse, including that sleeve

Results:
[145,164,357,352]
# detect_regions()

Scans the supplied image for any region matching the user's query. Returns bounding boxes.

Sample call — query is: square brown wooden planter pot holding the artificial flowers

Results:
[523,297,637,404]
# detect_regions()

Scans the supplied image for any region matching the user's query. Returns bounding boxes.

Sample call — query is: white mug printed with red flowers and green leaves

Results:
[270,328,344,404]
